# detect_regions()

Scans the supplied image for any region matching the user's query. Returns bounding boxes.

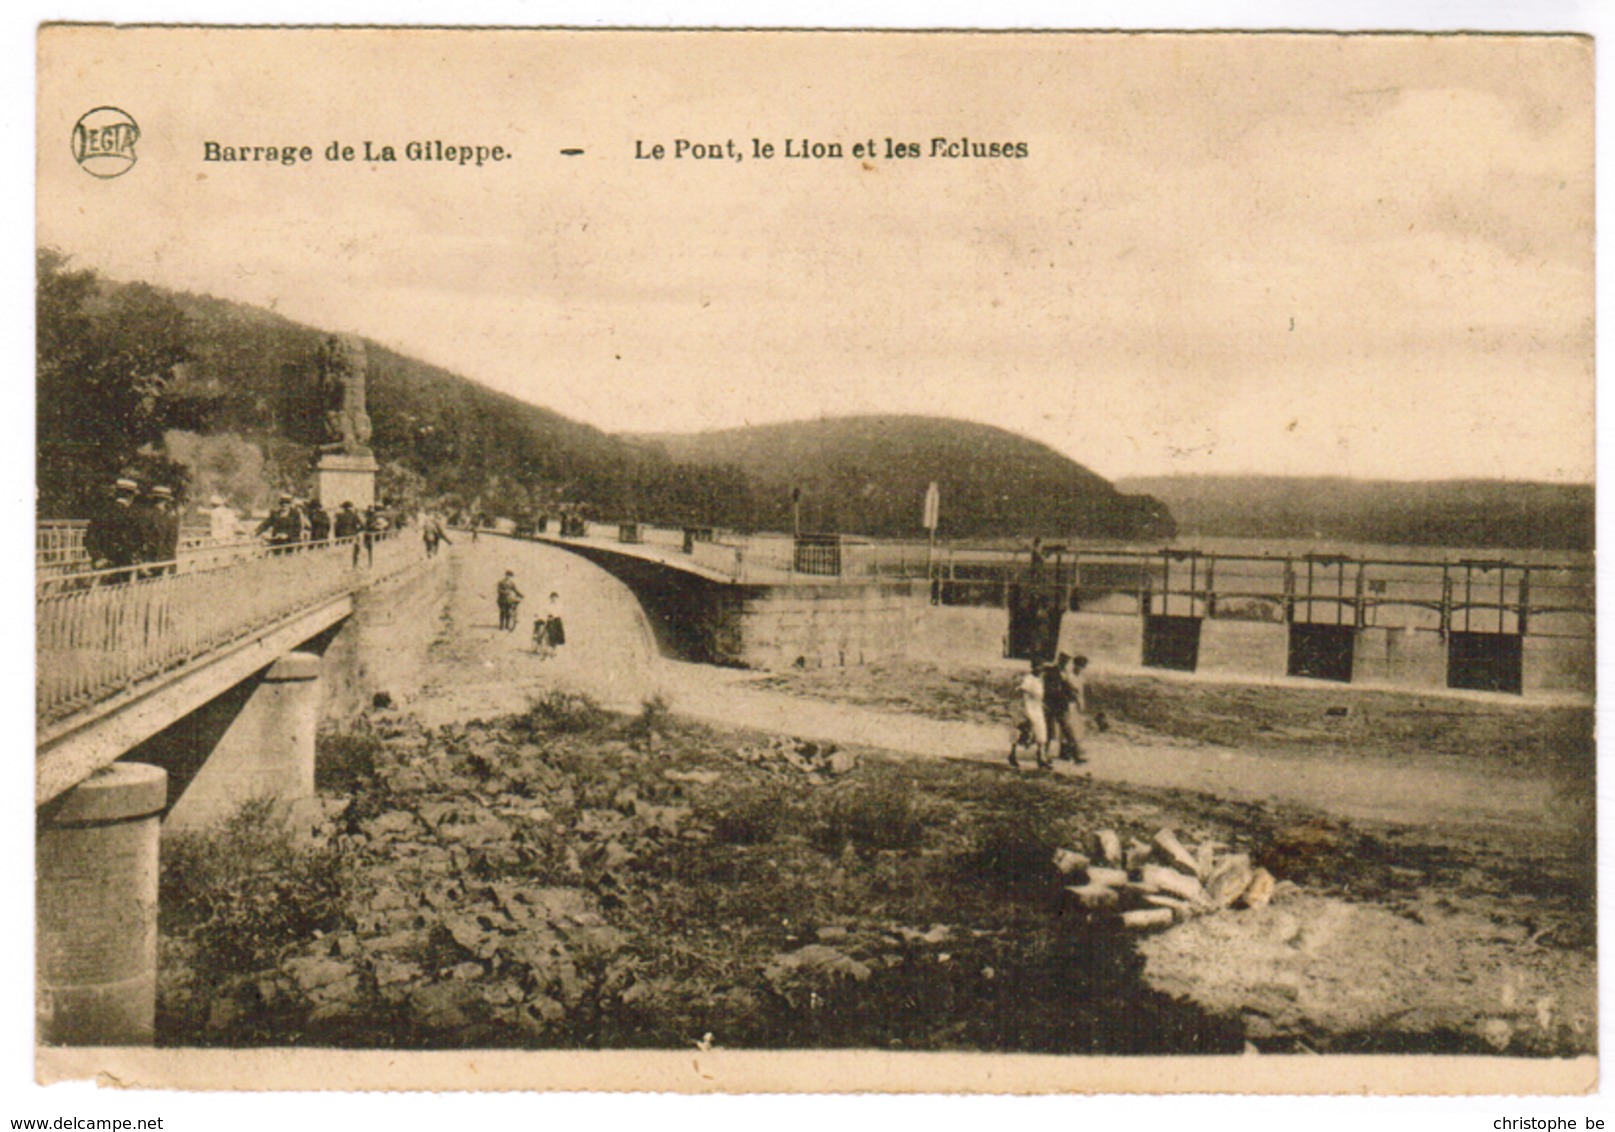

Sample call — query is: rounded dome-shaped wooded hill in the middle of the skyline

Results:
[636,417,1172,538]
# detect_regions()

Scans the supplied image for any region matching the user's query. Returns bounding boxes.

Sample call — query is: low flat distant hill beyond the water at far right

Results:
[1119,476,1594,551]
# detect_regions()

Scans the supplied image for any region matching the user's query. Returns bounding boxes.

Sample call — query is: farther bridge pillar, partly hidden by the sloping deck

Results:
[166,652,320,830]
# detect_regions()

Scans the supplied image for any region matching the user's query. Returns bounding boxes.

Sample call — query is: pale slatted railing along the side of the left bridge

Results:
[34,533,422,723]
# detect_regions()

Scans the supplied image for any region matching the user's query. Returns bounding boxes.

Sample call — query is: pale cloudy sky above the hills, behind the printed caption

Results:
[37,29,1594,481]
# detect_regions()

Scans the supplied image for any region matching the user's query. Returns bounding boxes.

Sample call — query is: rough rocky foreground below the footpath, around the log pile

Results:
[160,693,1594,1054]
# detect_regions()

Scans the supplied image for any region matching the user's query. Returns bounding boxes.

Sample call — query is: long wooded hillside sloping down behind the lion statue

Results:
[37,249,749,525]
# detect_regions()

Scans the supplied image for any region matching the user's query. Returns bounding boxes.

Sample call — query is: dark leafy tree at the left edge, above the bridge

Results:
[36,249,191,515]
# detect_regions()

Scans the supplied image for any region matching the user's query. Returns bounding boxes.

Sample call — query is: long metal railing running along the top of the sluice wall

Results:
[484,523,1596,638]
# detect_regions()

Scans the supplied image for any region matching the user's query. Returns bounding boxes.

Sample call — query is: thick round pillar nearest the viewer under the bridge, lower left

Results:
[34,762,168,1045]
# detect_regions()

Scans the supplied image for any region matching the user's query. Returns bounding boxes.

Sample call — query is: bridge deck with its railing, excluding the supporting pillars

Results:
[34,535,422,806]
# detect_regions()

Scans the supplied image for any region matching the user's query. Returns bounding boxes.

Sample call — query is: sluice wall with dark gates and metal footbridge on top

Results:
[518,522,1596,696]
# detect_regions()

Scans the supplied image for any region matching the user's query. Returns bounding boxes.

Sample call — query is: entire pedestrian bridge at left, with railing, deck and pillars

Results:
[34,535,433,1045]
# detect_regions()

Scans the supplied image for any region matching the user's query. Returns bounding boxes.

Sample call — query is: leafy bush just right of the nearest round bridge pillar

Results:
[162,799,347,975]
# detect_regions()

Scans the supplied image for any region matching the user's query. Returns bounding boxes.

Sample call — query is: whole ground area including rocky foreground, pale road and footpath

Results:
[158,539,1597,1056]
